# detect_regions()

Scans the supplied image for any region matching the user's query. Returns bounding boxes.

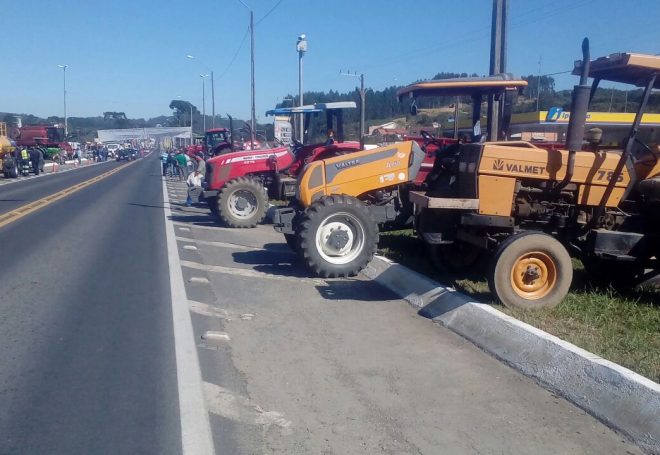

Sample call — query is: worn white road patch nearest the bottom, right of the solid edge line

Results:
[204,382,293,435]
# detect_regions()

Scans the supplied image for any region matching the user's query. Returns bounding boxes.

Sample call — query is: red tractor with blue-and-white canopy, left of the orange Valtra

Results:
[202,101,360,228]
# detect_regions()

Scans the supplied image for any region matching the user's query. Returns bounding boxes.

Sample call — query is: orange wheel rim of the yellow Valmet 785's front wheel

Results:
[511,251,557,300]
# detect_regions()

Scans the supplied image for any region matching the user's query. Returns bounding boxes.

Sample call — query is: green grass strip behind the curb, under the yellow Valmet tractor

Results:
[379,230,660,382]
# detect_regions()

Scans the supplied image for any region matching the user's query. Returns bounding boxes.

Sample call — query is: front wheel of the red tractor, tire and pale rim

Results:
[218,177,268,228]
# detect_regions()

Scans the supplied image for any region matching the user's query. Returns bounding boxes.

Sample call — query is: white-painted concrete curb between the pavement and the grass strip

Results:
[363,256,660,454]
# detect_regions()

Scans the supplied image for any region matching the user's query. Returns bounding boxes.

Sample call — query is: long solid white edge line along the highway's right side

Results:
[158,172,215,455]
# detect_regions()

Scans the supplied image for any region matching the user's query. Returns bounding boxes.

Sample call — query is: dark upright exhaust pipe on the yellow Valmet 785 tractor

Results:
[555,38,591,190]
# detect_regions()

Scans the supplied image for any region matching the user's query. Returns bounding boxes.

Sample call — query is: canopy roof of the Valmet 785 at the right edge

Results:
[573,53,660,88]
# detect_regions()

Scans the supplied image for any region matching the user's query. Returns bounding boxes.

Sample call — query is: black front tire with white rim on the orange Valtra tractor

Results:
[296,195,378,278]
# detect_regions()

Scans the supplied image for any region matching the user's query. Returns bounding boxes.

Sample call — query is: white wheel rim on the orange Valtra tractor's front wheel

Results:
[316,212,364,264]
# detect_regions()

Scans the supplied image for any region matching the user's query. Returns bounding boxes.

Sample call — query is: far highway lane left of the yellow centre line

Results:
[0,160,126,215]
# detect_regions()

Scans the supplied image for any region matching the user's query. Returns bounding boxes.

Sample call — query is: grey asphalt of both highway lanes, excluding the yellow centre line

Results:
[0,157,181,454]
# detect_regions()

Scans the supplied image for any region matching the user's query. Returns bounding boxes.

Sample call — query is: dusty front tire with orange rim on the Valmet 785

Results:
[488,232,573,310]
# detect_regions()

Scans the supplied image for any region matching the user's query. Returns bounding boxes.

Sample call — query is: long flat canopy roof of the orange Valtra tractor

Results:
[396,73,527,101]
